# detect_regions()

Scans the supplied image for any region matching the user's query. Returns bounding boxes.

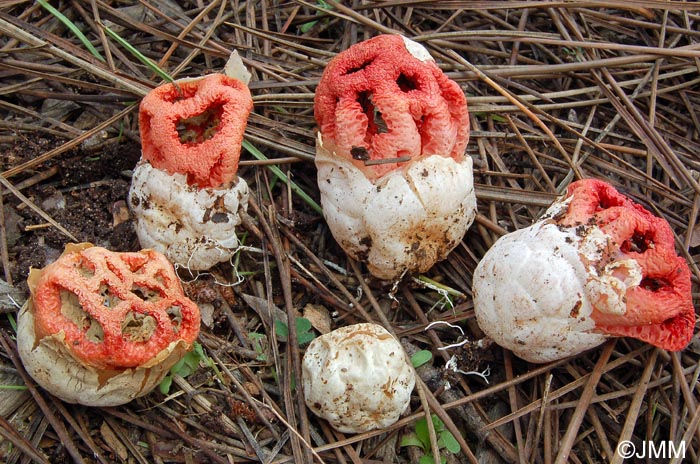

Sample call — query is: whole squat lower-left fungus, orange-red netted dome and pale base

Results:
[17,243,200,406]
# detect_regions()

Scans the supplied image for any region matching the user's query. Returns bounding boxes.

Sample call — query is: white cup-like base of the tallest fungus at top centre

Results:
[316,134,476,280]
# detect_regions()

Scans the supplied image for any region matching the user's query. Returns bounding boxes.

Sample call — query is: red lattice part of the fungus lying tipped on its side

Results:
[554,179,695,351]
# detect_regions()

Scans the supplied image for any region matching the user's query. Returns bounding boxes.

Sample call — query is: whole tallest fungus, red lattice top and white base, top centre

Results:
[314,35,476,280]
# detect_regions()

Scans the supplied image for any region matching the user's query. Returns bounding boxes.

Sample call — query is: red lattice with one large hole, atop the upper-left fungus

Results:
[139,74,253,188]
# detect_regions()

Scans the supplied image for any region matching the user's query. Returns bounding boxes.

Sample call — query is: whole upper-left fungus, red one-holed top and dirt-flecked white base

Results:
[129,74,253,270]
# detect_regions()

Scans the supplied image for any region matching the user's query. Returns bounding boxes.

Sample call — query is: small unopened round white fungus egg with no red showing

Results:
[302,323,416,433]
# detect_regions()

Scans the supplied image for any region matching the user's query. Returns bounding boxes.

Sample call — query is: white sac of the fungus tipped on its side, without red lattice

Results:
[473,196,641,362]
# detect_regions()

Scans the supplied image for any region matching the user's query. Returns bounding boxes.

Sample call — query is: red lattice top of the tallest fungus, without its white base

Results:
[314,35,469,178]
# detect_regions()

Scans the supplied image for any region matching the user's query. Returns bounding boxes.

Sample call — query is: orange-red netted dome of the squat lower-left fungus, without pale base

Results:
[33,247,200,369]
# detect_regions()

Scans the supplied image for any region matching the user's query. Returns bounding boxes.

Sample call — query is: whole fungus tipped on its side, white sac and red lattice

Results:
[474,179,695,362]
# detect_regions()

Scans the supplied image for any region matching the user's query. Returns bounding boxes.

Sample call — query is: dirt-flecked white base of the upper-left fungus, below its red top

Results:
[129,162,248,270]
